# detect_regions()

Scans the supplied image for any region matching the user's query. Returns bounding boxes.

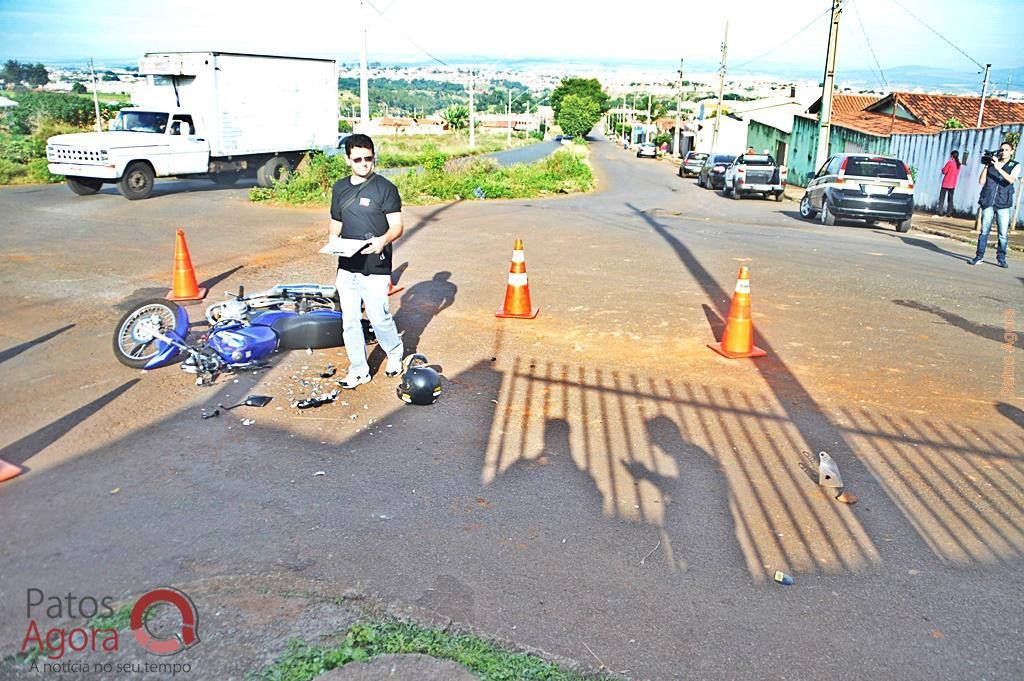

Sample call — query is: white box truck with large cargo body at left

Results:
[46,52,338,200]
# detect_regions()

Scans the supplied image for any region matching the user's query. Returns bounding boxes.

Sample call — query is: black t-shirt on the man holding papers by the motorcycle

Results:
[331,173,401,274]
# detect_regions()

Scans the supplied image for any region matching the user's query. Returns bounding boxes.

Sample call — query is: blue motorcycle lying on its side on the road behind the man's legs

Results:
[114,284,377,385]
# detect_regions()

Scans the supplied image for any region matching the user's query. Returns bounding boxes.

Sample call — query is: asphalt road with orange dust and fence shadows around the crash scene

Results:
[0,134,1024,680]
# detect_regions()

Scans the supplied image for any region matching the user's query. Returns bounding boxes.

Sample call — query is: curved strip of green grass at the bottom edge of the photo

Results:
[248,621,611,681]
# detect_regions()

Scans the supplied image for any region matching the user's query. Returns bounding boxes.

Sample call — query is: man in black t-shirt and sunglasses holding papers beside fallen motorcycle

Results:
[330,134,404,389]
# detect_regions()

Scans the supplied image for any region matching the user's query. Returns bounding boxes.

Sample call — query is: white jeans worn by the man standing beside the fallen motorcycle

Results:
[337,269,404,376]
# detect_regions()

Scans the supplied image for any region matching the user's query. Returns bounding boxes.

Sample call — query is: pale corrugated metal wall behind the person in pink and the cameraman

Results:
[889,124,1024,219]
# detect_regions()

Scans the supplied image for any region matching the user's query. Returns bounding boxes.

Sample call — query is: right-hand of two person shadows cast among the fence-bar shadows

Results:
[626,416,745,571]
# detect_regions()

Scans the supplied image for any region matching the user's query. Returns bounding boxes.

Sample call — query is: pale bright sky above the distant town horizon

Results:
[0,0,1024,77]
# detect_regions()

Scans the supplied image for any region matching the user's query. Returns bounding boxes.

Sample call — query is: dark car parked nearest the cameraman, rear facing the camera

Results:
[800,154,913,231]
